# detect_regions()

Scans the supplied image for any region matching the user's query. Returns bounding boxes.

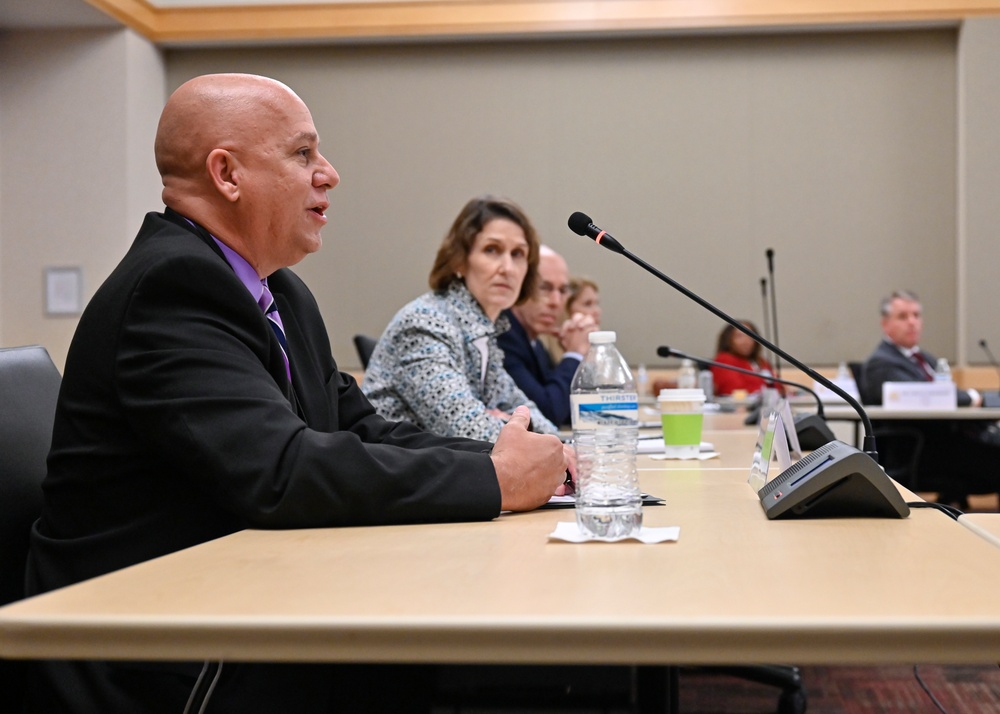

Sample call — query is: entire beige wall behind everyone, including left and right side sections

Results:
[0,20,1000,367]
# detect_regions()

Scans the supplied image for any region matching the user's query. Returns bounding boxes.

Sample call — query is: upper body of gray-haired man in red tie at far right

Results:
[858,290,983,407]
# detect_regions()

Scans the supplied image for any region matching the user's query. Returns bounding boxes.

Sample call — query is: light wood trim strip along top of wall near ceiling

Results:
[87,0,1000,46]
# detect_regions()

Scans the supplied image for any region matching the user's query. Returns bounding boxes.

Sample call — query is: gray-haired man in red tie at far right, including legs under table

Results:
[858,290,1000,505]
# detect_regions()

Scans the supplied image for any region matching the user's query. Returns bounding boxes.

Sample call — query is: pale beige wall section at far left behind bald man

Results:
[0,30,165,367]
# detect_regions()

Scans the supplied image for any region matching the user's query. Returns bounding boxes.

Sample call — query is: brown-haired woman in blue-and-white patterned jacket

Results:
[362,196,557,441]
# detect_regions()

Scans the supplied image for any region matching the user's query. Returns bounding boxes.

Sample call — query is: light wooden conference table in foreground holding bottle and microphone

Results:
[0,415,1000,665]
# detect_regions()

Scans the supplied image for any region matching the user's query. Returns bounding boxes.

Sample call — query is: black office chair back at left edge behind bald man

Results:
[0,346,62,712]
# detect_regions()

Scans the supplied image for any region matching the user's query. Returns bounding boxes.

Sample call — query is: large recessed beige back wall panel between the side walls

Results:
[168,30,957,364]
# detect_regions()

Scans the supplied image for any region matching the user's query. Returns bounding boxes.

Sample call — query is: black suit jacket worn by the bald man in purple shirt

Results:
[27,210,500,712]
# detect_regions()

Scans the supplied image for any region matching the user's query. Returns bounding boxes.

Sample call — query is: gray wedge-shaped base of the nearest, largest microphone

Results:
[757,441,910,520]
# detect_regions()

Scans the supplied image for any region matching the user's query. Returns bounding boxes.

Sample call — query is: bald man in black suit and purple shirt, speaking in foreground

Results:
[27,75,572,714]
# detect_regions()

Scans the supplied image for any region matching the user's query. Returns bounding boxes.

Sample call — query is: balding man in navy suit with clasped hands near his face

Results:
[497,246,597,425]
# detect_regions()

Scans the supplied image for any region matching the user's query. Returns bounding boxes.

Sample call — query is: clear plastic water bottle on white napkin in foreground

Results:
[570,331,642,539]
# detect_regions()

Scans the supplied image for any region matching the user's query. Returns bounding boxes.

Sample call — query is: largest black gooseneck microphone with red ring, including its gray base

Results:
[568,211,910,518]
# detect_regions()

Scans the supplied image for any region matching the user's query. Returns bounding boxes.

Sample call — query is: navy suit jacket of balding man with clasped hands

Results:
[497,310,580,426]
